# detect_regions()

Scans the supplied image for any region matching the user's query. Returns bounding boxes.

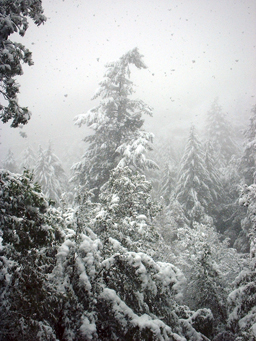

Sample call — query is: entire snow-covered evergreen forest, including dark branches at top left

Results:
[0,1,256,341]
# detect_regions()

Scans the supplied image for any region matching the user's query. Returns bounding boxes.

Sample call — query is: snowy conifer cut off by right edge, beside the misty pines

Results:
[240,105,256,185]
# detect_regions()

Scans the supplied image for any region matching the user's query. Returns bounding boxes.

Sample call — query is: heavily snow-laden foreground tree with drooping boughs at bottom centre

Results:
[50,185,212,341]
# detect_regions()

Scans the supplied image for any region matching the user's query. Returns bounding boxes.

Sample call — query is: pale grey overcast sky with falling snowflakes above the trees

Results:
[0,0,256,166]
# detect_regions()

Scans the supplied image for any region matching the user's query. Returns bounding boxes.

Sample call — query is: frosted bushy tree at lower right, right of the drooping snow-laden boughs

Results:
[170,223,248,340]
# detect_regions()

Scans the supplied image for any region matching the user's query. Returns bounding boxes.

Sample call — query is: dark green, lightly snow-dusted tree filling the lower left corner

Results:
[0,171,62,341]
